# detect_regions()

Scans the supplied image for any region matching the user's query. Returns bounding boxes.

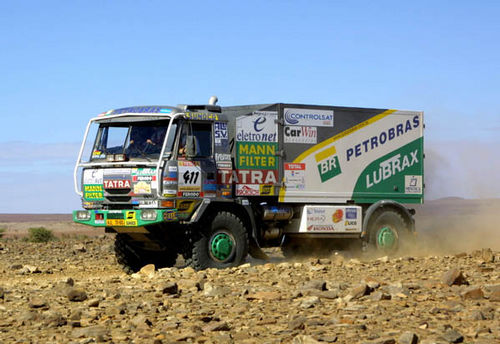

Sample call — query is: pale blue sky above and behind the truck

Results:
[0,1,500,213]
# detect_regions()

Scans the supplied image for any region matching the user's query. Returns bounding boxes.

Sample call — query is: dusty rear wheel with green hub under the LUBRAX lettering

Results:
[368,209,413,255]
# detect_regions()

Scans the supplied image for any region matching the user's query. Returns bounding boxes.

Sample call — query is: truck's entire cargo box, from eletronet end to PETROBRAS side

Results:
[223,104,424,203]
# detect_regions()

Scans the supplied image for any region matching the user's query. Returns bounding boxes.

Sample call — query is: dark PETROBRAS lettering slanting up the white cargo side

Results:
[346,115,420,161]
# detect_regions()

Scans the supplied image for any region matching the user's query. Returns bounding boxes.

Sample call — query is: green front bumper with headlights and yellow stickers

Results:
[73,209,178,228]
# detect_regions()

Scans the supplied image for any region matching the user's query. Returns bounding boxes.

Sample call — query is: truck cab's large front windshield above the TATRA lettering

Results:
[91,120,177,161]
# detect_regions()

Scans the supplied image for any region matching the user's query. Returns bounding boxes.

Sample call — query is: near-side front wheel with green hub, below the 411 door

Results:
[191,211,248,270]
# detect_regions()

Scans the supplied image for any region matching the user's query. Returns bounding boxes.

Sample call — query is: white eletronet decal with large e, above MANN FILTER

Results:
[236,112,278,142]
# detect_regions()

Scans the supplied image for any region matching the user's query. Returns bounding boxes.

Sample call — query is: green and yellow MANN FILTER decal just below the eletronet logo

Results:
[236,142,278,170]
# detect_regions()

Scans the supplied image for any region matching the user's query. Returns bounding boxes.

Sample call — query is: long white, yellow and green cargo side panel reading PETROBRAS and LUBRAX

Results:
[280,105,423,203]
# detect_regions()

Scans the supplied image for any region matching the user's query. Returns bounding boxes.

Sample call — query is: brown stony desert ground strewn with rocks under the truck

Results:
[0,235,500,344]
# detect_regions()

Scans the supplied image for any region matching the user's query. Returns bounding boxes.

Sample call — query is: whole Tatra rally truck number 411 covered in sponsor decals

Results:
[73,97,424,272]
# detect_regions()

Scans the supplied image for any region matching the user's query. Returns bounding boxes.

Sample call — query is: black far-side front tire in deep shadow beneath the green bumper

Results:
[115,234,177,274]
